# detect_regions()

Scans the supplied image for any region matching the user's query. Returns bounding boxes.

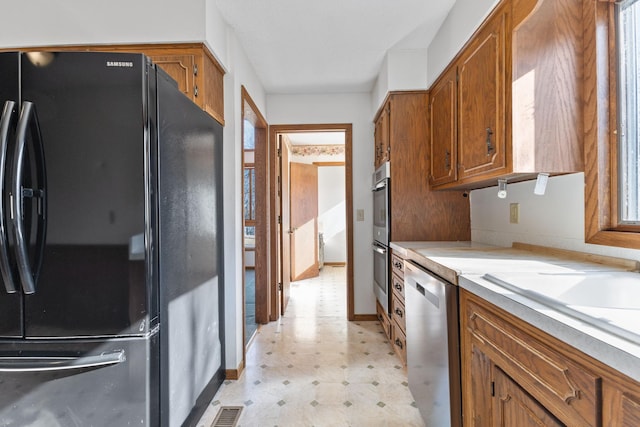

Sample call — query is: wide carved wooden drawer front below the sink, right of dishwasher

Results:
[461,301,601,426]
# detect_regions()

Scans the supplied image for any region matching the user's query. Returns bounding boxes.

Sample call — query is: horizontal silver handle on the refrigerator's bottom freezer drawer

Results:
[0,350,127,372]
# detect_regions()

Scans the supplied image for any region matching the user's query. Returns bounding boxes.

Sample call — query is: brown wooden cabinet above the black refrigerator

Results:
[5,43,224,125]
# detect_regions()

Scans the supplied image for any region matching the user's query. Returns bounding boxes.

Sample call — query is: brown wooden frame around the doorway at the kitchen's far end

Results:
[269,123,355,321]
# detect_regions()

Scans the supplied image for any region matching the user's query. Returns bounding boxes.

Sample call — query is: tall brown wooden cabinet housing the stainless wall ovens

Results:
[374,91,471,241]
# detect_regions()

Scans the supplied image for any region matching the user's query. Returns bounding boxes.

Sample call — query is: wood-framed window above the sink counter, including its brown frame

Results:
[583,0,640,249]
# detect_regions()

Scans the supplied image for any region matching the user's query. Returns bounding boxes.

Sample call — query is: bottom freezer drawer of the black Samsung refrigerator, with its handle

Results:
[0,334,159,427]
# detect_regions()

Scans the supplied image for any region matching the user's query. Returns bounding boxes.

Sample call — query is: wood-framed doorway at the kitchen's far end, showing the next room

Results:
[269,124,354,320]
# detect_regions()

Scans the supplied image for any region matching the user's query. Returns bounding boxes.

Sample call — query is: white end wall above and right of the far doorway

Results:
[267,93,376,314]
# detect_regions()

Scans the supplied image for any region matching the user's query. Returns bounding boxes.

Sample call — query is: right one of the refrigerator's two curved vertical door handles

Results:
[11,101,47,294]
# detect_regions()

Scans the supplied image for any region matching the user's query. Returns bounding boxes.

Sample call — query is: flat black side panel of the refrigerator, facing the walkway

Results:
[158,72,224,426]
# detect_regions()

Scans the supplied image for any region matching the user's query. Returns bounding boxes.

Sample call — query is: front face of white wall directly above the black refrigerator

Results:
[0,0,206,47]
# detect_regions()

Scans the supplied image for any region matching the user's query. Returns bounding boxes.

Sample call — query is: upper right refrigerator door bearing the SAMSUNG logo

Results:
[21,52,155,338]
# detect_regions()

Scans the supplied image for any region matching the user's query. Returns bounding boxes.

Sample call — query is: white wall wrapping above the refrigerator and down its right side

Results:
[0,0,266,369]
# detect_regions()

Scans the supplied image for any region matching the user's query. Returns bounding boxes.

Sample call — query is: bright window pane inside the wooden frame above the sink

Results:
[615,0,640,226]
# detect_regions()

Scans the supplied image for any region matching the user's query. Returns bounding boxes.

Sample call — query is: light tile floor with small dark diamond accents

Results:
[198,266,424,427]
